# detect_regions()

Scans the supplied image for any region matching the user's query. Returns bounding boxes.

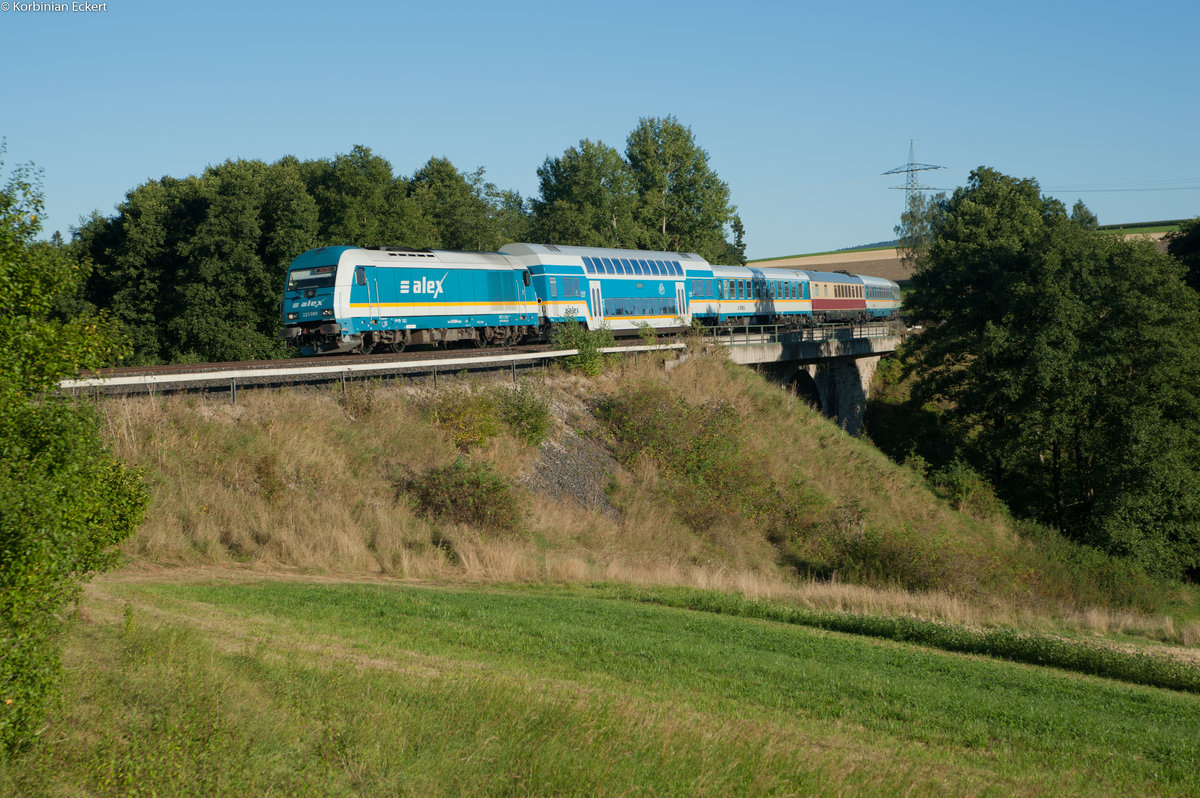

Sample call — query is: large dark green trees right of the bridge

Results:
[872,168,1200,577]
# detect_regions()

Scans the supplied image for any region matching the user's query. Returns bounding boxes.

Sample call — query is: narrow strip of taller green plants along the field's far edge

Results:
[612,586,1200,692]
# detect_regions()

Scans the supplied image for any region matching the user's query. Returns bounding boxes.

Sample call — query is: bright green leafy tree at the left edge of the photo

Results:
[0,153,146,751]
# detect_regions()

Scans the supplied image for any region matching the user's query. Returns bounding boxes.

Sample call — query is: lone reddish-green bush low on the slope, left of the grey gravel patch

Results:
[402,457,522,532]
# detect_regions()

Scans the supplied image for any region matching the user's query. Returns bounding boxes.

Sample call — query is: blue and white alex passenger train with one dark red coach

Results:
[280,244,900,355]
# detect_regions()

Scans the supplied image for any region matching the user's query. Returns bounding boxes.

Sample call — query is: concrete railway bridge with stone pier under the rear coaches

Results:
[705,323,900,436]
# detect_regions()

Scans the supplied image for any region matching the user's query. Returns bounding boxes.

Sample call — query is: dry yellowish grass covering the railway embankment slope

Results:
[103,358,1178,638]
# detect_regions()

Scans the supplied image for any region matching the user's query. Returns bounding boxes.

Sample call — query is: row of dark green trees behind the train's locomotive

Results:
[60,116,745,364]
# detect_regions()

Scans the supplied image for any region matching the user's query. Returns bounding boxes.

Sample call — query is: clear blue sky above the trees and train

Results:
[0,0,1200,258]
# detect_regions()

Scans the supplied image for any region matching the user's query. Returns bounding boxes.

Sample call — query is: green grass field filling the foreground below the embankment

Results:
[0,575,1200,796]
